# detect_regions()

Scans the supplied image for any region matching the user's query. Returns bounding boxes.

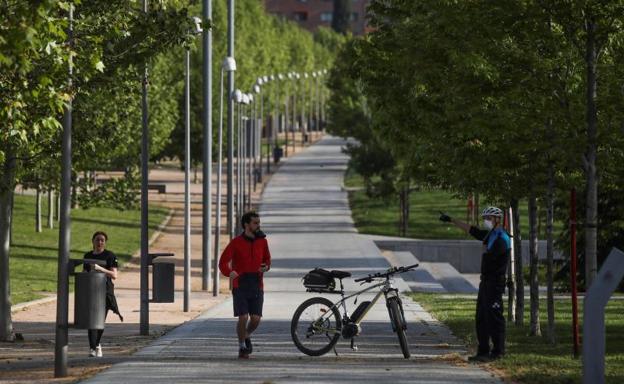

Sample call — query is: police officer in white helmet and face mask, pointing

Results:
[440,207,511,362]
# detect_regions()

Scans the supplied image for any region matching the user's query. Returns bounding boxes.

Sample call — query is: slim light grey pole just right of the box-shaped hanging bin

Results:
[184,49,190,312]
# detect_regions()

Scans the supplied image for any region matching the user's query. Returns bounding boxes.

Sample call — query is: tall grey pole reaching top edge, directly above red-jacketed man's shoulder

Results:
[227,0,234,239]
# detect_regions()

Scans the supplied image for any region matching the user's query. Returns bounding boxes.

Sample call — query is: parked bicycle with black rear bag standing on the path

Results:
[290,264,418,359]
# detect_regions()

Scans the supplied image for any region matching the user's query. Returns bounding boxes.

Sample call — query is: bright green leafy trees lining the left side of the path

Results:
[0,0,342,340]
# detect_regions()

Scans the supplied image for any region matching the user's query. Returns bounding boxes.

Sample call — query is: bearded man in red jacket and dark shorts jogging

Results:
[219,212,271,359]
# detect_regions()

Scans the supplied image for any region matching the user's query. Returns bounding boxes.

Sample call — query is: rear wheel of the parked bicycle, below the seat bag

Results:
[290,297,342,356]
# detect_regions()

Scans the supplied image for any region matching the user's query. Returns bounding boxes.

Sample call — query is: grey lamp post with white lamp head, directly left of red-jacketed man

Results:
[212,57,236,296]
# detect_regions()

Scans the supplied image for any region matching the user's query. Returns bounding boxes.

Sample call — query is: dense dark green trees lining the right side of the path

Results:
[330,0,624,339]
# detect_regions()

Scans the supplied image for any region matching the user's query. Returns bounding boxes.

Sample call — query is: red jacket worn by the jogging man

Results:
[219,234,271,288]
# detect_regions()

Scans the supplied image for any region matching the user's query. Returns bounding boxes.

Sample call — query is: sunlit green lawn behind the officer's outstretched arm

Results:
[344,169,563,239]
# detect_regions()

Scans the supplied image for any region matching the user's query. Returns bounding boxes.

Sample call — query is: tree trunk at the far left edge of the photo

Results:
[0,151,17,341]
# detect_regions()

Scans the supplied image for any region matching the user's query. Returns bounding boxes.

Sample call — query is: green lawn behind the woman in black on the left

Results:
[9,195,168,304]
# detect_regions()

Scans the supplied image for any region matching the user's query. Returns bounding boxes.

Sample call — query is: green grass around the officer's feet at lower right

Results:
[411,293,624,384]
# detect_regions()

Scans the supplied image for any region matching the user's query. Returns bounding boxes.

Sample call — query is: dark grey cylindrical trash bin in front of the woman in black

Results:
[74,272,106,329]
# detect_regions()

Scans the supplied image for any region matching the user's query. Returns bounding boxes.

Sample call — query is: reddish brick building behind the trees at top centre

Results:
[264,0,370,35]
